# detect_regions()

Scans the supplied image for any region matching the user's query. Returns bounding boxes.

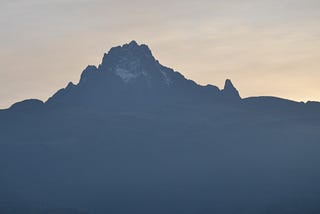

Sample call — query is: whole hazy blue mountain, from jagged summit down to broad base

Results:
[0,41,320,214]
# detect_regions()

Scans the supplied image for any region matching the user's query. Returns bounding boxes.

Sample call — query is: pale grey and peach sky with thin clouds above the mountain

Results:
[0,0,320,108]
